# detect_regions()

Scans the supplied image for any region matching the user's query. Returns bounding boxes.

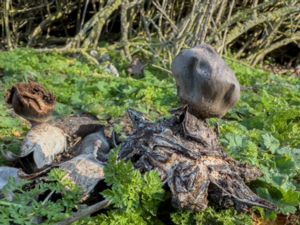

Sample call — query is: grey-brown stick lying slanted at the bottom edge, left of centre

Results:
[56,200,111,225]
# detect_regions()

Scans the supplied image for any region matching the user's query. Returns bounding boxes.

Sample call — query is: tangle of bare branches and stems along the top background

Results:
[0,0,300,69]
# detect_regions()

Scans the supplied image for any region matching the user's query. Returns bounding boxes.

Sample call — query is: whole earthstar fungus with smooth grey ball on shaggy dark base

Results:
[120,44,276,211]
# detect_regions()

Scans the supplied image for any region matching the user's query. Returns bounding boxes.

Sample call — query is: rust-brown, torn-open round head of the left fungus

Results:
[6,82,55,123]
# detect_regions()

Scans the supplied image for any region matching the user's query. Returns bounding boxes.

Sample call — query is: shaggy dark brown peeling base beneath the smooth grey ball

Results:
[120,108,275,211]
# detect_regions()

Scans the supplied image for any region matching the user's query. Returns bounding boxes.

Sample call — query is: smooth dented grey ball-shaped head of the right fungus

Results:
[172,44,240,119]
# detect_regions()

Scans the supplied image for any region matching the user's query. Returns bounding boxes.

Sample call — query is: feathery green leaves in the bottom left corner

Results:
[0,169,82,225]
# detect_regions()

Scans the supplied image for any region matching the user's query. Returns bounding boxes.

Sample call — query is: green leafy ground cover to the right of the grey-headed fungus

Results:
[218,61,300,218]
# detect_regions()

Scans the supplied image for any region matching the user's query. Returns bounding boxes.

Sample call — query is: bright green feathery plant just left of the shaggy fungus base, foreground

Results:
[74,150,166,225]
